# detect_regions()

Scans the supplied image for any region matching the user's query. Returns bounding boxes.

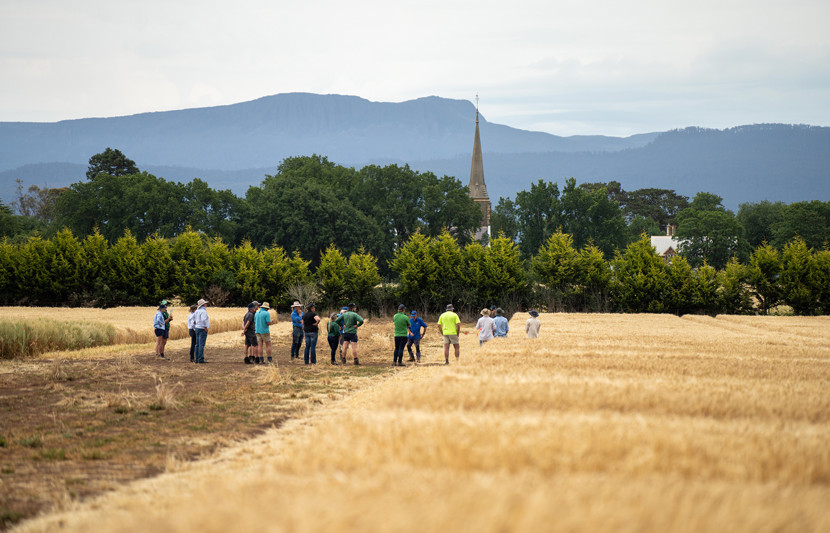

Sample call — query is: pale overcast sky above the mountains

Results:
[0,0,830,135]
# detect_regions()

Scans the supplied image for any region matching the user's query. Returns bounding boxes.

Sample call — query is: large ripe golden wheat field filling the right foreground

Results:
[11,313,830,532]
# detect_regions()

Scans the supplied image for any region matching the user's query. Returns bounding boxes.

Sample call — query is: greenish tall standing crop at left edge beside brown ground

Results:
[0,320,116,359]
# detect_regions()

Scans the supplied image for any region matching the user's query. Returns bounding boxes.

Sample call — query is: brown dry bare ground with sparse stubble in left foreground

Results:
[0,324,404,530]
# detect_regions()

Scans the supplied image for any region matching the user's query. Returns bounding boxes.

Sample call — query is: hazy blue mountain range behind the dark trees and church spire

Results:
[0,93,830,209]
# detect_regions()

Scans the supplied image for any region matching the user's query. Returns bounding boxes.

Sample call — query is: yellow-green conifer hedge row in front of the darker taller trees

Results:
[0,224,830,315]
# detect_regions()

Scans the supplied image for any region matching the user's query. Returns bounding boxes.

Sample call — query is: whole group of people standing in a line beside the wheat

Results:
[153,299,541,366]
